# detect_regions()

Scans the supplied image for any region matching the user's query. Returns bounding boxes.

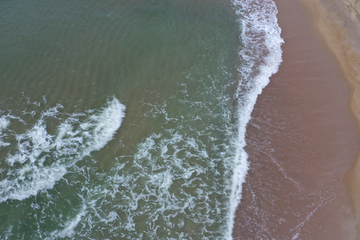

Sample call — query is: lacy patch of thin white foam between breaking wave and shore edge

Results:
[66,130,228,239]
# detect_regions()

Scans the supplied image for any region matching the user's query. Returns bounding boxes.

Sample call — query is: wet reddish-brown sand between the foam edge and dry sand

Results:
[234,0,359,239]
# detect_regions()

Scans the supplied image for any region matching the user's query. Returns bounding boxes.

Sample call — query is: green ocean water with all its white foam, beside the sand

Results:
[0,0,282,239]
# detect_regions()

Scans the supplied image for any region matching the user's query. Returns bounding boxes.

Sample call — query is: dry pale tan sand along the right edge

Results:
[300,0,360,234]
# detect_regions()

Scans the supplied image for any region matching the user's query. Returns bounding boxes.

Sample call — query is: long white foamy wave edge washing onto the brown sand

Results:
[226,0,284,239]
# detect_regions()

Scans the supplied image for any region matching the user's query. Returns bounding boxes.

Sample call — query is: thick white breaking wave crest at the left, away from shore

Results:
[0,98,125,202]
